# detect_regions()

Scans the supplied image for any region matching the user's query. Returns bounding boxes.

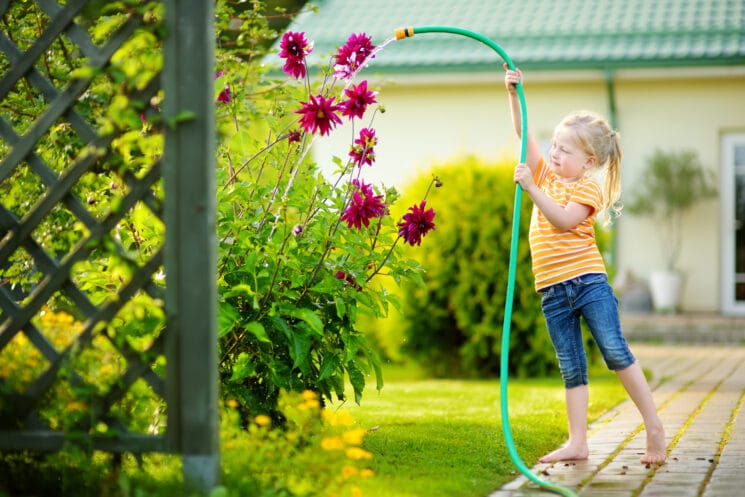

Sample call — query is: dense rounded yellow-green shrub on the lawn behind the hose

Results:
[392,157,555,376]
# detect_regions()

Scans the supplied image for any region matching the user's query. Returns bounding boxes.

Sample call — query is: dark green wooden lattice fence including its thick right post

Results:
[0,0,219,485]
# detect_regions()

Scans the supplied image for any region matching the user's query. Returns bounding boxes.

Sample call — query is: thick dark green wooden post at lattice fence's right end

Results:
[163,0,220,493]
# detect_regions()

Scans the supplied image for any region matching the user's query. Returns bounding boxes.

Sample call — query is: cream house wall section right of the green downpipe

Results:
[617,77,745,311]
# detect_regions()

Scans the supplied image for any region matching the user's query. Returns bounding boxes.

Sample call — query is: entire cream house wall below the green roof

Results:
[314,70,745,312]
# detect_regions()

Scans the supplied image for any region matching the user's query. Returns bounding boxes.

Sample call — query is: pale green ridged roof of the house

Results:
[288,0,745,73]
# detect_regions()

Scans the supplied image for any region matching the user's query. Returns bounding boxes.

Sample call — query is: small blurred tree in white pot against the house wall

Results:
[626,149,717,312]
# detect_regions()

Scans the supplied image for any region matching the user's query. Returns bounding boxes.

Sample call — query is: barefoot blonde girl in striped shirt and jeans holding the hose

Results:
[505,65,666,464]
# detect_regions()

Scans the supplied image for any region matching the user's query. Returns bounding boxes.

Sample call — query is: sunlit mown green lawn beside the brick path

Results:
[346,360,626,497]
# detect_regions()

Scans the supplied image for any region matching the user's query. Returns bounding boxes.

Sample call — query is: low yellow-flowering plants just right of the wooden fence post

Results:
[221,390,373,497]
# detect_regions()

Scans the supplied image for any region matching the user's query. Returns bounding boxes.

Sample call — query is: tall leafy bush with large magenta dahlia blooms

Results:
[215,26,435,414]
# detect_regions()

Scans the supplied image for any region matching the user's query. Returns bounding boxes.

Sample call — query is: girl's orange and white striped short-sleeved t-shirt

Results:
[529,159,606,291]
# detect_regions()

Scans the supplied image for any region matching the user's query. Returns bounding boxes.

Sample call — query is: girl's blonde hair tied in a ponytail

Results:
[556,111,623,224]
